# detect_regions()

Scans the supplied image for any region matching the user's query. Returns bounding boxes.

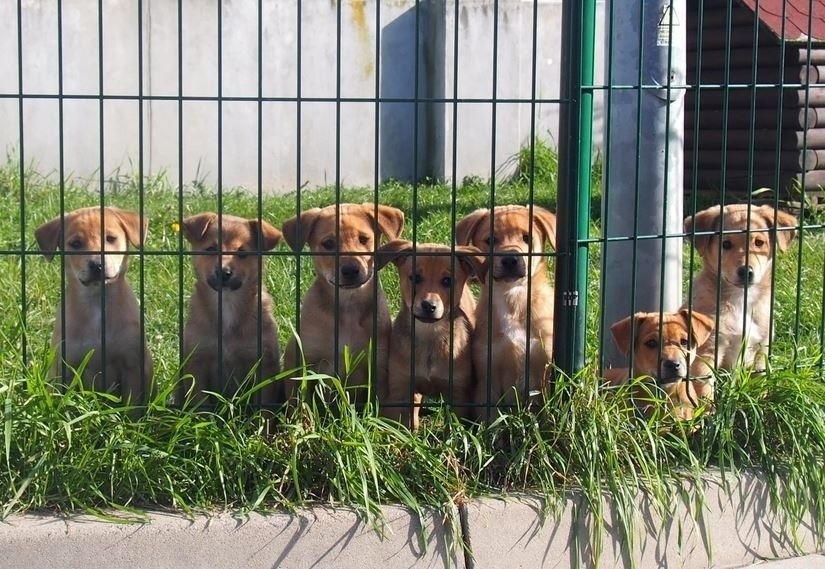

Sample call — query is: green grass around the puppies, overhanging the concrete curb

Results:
[0,142,825,555]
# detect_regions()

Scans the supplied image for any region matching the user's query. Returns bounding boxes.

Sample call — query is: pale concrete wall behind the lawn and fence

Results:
[0,0,603,191]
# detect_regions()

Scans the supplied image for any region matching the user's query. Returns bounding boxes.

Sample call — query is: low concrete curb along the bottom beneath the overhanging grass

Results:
[0,475,825,569]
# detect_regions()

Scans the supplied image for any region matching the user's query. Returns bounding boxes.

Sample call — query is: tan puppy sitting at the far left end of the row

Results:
[35,206,152,404]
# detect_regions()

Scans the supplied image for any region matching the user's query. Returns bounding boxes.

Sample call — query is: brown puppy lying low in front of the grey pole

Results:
[604,308,713,419]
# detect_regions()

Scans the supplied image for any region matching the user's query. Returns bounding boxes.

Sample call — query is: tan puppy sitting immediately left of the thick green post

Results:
[455,205,556,412]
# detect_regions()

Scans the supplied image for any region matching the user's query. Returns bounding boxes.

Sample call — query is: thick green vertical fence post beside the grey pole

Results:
[553,0,596,376]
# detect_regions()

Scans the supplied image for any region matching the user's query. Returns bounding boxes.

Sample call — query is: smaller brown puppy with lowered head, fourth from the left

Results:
[376,240,484,429]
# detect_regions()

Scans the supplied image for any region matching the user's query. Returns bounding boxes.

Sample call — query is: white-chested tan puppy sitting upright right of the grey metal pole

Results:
[685,204,798,370]
